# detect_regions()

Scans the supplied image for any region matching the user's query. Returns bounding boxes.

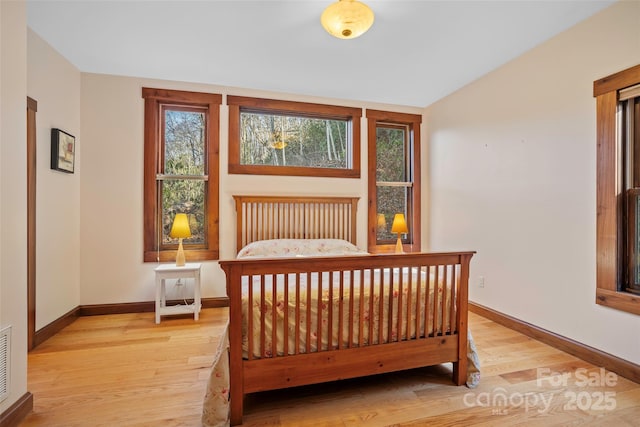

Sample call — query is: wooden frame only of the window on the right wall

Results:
[593,65,640,314]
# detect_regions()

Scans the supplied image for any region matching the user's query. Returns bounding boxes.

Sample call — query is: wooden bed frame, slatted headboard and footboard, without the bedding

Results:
[220,196,474,425]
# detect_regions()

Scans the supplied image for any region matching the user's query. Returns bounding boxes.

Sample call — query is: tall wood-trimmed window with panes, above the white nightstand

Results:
[142,88,222,262]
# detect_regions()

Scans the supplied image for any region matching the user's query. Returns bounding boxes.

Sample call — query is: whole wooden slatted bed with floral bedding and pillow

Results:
[205,196,477,425]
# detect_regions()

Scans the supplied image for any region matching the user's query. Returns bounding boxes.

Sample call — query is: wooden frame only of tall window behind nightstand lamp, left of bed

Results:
[142,87,222,262]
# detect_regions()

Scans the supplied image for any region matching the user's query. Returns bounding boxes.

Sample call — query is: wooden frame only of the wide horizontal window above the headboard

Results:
[227,95,362,178]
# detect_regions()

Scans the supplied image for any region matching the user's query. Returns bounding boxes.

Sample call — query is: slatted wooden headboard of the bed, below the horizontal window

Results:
[233,196,359,253]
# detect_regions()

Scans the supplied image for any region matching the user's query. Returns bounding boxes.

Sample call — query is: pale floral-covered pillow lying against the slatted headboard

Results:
[238,239,366,258]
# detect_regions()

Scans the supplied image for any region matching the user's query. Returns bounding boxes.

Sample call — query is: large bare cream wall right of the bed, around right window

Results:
[425,1,640,363]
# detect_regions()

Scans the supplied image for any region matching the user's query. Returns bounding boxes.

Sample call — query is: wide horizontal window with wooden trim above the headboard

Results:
[227,96,362,178]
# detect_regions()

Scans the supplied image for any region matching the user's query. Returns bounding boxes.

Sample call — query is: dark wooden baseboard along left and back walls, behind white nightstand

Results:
[33,297,229,348]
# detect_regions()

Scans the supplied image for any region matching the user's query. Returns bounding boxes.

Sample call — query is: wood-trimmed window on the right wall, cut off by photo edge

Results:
[593,65,640,314]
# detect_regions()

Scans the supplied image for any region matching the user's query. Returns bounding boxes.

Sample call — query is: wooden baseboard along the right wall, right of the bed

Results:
[469,301,640,383]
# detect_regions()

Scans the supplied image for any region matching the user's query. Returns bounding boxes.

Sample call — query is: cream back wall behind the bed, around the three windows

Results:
[80,74,422,304]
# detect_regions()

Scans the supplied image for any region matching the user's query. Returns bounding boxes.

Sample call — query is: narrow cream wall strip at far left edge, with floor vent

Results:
[0,1,27,414]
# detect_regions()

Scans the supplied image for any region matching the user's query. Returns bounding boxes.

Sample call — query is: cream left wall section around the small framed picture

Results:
[27,30,83,330]
